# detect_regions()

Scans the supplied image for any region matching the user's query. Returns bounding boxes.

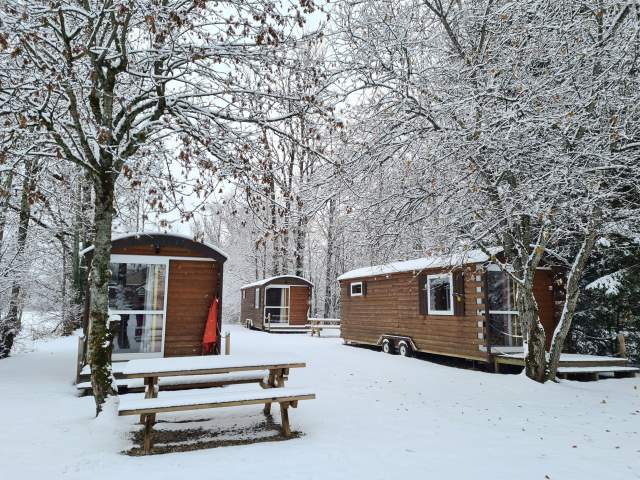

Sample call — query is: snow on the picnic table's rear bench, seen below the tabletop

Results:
[76,370,269,391]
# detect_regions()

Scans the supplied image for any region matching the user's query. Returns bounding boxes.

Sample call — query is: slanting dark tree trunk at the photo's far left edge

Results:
[0,159,37,358]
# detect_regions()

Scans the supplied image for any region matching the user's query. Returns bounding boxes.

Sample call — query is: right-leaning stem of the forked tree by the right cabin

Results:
[547,228,597,380]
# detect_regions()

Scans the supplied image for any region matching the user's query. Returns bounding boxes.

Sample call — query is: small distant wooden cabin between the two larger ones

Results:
[240,275,313,332]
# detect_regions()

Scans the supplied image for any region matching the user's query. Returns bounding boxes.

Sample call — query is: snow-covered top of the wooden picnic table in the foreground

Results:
[122,355,306,378]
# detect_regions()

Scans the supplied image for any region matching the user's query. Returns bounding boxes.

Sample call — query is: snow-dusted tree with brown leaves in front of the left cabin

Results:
[0,0,324,413]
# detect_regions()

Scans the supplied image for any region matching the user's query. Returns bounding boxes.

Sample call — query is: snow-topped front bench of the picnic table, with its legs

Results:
[118,387,316,455]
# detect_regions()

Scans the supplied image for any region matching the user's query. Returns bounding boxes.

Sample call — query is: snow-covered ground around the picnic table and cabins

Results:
[0,326,640,480]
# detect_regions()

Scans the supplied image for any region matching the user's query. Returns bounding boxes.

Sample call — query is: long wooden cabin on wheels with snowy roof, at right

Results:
[338,251,559,362]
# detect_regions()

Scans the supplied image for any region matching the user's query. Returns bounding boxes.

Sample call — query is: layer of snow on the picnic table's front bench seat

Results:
[118,387,315,411]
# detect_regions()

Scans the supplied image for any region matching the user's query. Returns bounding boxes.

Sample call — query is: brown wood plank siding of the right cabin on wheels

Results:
[340,265,554,361]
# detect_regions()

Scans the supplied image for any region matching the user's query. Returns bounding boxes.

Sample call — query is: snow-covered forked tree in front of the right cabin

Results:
[338,0,640,382]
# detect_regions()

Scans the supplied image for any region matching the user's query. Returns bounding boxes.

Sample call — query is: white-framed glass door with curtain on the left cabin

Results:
[109,255,169,358]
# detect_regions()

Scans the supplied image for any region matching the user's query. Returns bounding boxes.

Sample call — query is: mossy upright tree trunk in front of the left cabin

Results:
[88,174,115,416]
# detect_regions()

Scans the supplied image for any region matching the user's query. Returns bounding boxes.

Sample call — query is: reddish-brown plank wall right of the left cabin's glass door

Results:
[164,260,220,357]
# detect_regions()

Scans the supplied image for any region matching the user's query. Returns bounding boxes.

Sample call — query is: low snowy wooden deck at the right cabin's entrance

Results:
[494,353,640,380]
